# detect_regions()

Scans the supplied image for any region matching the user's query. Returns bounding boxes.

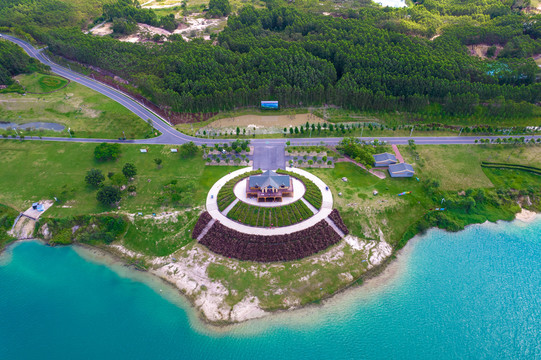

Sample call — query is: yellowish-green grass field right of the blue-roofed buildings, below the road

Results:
[399,145,541,190]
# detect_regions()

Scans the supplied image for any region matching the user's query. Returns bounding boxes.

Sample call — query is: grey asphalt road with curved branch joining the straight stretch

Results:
[2,34,540,146]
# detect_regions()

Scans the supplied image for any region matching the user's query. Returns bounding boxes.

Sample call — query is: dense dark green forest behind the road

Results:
[0,0,541,117]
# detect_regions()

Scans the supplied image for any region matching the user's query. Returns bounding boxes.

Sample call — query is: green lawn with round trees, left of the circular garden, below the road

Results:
[0,140,238,217]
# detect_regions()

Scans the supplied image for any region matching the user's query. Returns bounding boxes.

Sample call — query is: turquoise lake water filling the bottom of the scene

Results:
[0,218,541,360]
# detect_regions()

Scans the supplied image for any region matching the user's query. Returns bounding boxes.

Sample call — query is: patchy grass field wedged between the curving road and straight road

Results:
[0,74,156,139]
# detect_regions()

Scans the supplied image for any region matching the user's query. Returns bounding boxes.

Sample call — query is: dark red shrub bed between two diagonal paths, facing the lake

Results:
[200,220,340,262]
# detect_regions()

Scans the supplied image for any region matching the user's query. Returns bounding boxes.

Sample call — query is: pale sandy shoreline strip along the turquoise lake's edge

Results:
[0,209,540,332]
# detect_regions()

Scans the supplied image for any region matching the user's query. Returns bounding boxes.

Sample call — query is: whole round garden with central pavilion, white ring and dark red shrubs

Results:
[192,167,348,262]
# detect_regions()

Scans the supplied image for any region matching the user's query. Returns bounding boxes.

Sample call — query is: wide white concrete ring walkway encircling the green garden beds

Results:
[207,167,333,236]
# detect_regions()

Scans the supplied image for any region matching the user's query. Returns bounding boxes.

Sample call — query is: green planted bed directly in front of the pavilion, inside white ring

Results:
[227,200,314,227]
